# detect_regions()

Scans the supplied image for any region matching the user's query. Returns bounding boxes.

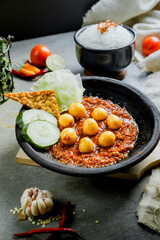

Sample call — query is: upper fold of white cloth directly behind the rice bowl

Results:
[83,0,159,26]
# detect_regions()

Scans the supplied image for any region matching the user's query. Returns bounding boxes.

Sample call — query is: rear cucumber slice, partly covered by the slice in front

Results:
[16,109,57,128]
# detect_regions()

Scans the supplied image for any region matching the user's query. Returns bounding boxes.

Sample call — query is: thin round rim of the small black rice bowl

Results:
[74,24,136,53]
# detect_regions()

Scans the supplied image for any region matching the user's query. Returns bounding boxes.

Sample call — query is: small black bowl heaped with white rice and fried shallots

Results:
[74,21,136,76]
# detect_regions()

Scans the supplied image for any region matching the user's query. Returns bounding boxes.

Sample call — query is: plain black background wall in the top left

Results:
[0,0,98,40]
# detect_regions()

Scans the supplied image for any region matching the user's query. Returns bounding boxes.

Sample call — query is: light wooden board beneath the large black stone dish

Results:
[16,142,160,180]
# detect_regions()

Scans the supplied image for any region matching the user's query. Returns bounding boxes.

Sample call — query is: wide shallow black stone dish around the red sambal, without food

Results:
[16,77,160,176]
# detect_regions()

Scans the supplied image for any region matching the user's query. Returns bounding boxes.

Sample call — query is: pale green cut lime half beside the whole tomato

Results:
[46,54,65,71]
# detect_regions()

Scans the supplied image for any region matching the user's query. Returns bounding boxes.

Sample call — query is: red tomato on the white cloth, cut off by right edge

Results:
[142,36,160,56]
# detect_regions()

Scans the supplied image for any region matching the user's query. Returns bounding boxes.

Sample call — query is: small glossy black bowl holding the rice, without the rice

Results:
[74,25,136,76]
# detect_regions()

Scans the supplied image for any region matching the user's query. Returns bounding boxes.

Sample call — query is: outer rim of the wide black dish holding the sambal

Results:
[15,76,160,176]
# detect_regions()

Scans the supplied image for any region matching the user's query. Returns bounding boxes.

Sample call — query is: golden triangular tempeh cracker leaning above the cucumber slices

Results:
[4,90,59,118]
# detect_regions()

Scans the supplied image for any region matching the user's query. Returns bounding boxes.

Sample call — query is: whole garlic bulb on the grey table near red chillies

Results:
[20,187,54,217]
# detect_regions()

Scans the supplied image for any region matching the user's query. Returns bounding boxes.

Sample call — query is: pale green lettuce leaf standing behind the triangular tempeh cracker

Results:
[31,69,84,112]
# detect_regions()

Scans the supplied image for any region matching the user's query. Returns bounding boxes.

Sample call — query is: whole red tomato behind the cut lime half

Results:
[30,44,52,67]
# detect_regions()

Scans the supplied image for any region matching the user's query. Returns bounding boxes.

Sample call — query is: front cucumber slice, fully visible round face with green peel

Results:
[21,120,60,148]
